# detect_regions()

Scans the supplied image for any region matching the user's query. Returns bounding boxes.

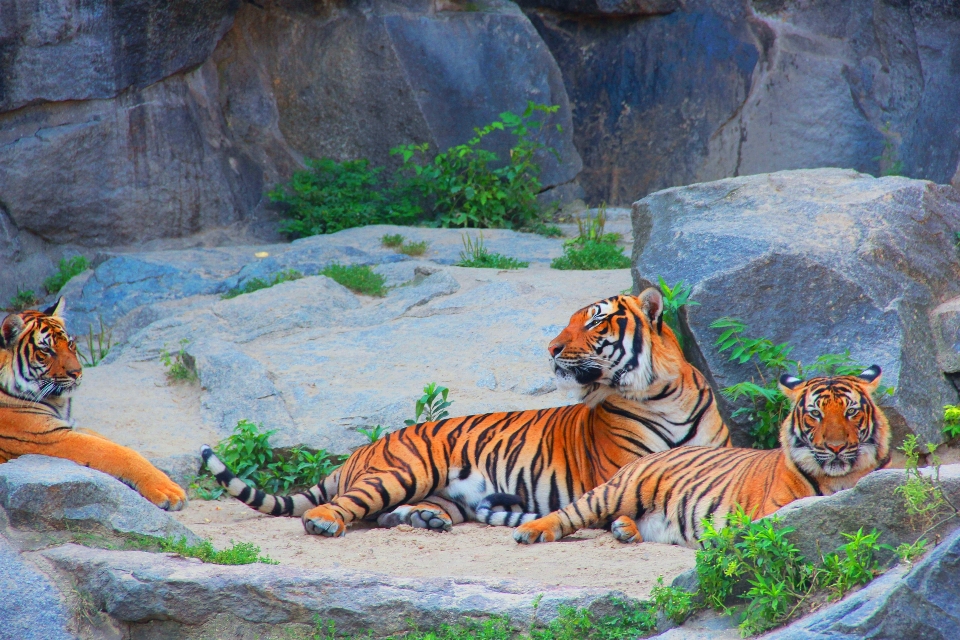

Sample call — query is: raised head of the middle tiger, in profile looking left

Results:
[548,287,689,406]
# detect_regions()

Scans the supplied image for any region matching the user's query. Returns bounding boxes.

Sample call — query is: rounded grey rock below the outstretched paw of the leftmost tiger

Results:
[0,455,199,543]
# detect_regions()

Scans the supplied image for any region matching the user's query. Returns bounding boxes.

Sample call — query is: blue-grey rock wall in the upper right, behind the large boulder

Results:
[522,0,960,203]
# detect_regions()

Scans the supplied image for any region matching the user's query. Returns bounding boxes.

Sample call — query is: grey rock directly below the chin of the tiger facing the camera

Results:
[775,464,960,564]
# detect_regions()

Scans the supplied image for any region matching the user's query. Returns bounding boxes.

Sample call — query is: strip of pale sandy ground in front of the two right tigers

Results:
[175,500,694,598]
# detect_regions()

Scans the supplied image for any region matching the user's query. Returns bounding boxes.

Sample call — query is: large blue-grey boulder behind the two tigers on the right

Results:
[633,169,960,445]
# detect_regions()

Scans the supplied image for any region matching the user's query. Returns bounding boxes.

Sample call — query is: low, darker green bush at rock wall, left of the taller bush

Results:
[267,158,421,238]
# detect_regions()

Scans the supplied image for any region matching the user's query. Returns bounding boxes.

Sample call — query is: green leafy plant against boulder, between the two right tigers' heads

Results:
[710,318,893,449]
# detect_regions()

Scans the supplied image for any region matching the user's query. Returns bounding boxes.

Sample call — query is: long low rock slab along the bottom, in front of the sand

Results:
[42,545,632,638]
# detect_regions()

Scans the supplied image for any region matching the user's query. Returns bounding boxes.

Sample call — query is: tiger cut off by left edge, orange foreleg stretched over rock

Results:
[0,298,187,511]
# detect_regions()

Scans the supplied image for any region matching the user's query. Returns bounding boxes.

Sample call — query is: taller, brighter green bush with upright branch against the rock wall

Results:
[390,102,559,229]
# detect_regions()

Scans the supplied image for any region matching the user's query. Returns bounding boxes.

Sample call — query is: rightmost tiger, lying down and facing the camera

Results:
[513,365,890,547]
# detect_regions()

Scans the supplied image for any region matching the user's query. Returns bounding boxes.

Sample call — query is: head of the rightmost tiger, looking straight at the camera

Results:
[780,365,890,478]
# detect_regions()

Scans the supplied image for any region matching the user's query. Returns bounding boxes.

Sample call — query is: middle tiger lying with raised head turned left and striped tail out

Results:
[201,289,729,536]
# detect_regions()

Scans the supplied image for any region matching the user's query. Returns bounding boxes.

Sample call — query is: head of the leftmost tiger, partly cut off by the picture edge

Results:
[0,297,83,401]
